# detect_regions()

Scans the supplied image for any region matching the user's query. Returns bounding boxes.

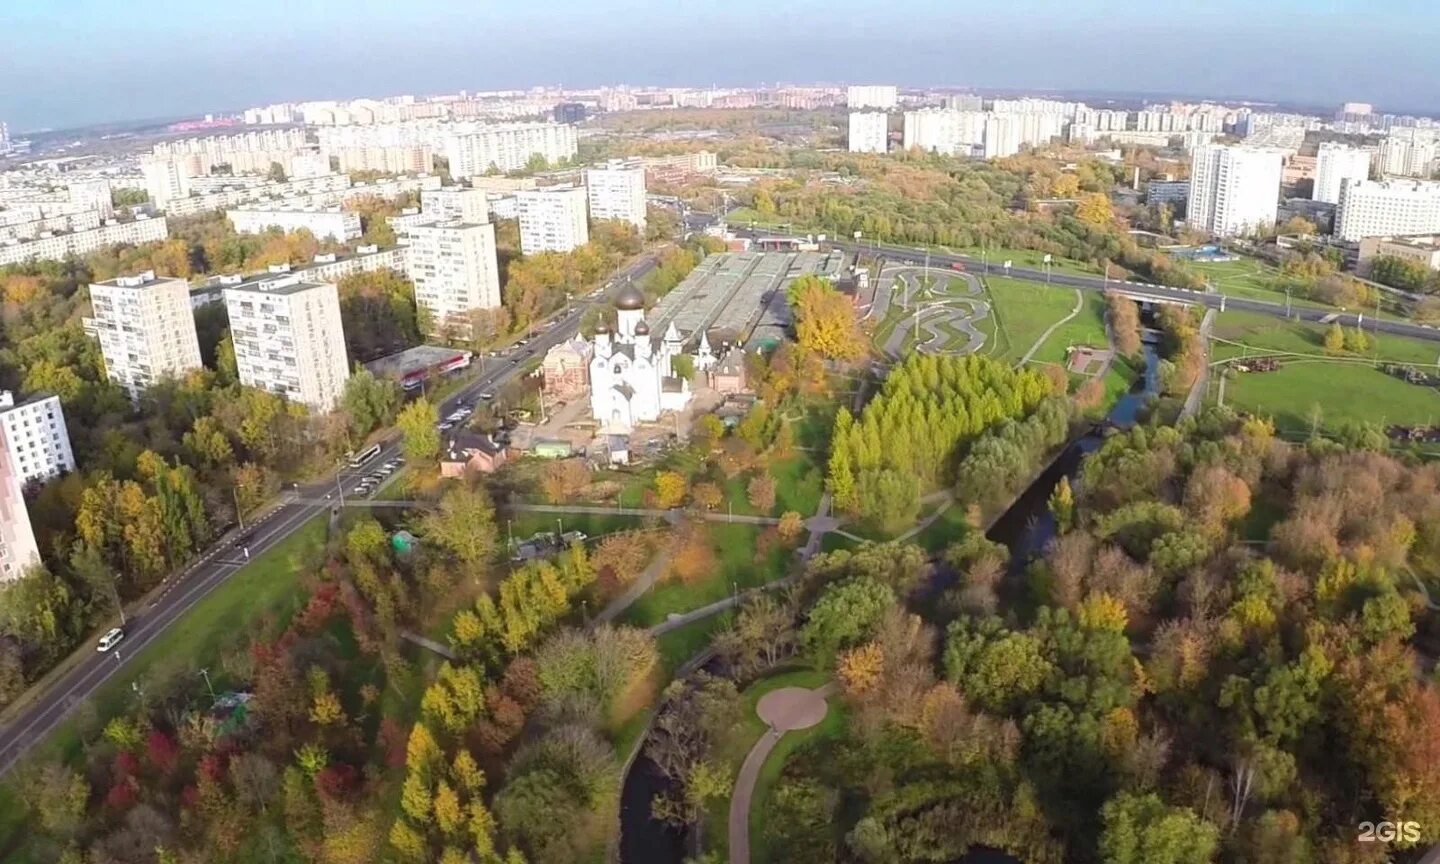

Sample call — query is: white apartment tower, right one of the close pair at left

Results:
[225,276,350,412]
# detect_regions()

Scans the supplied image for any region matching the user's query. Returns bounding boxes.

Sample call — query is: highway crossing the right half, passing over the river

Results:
[766,229,1440,351]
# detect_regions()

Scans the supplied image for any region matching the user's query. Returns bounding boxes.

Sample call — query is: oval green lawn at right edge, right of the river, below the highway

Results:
[1211,360,1440,435]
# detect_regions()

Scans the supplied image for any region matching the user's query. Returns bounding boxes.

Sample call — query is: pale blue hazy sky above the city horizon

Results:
[0,0,1440,131]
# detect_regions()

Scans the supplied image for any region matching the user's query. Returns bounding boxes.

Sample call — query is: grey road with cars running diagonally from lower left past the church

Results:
[0,256,655,776]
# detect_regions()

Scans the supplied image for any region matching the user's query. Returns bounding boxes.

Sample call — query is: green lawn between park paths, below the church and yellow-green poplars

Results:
[622,523,792,626]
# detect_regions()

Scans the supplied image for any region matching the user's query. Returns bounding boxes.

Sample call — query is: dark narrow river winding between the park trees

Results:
[621,346,1159,864]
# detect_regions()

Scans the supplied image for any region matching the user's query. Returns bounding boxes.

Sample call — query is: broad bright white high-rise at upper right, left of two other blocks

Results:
[1185,144,1282,238]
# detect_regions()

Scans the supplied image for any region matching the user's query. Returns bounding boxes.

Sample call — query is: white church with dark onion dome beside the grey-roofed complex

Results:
[590,285,714,435]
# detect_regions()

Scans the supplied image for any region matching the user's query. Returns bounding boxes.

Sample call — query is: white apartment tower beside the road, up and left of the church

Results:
[409,218,506,337]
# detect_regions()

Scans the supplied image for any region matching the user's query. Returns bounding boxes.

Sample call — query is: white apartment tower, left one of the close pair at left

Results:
[85,271,200,399]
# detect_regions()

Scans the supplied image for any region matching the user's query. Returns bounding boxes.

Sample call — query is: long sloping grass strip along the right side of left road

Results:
[0,514,328,848]
